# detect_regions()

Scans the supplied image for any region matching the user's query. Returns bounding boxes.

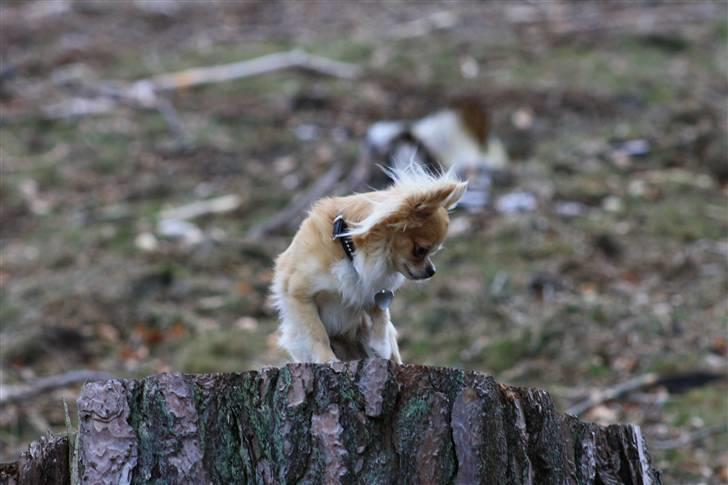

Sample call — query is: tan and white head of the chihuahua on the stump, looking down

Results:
[352,166,467,280]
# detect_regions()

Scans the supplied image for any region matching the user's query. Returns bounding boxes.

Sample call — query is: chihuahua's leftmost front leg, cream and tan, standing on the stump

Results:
[279,296,339,364]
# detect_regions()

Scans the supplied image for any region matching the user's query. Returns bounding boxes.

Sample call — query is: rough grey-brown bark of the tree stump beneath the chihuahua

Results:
[0,359,660,484]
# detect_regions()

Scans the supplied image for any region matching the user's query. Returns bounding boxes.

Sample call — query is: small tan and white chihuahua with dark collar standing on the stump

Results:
[272,164,467,363]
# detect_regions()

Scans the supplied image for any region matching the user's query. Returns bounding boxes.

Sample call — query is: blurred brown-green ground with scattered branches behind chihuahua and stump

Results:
[0,0,728,483]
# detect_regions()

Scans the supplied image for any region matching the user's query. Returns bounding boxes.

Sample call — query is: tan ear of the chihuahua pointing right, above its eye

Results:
[386,182,468,230]
